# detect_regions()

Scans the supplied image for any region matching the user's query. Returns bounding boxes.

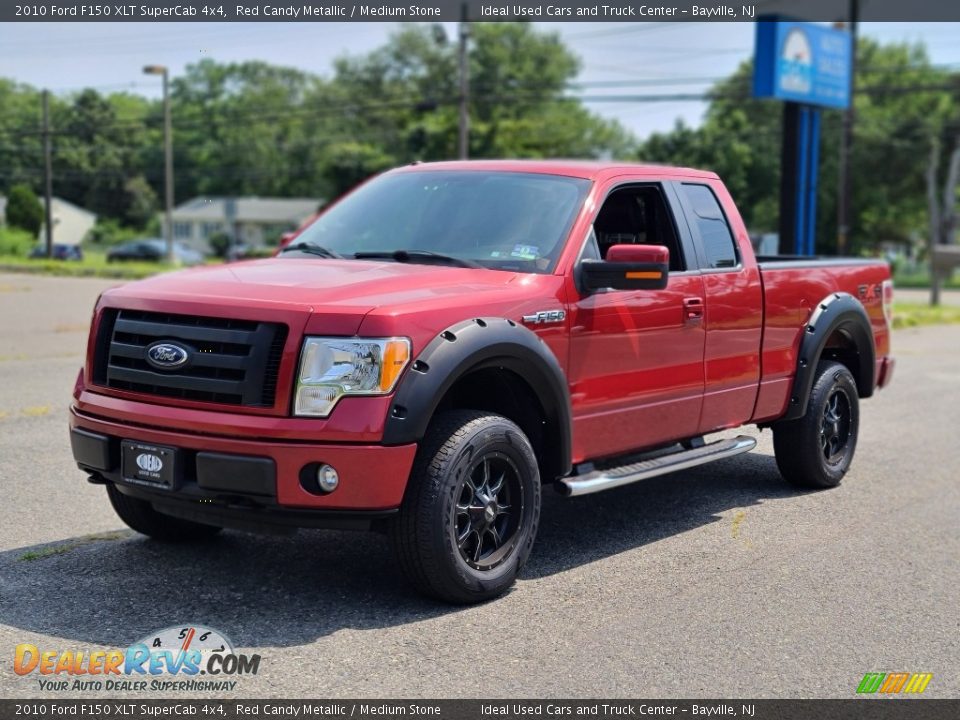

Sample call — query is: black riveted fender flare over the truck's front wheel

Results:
[383,317,572,479]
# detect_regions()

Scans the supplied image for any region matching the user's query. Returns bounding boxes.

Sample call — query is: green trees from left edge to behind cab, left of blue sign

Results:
[0,23,634,239]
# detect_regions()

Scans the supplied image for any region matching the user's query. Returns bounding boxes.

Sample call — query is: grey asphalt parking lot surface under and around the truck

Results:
[0,275,960,698]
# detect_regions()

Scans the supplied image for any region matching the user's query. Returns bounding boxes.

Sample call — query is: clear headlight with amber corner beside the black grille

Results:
[293,337,410,417]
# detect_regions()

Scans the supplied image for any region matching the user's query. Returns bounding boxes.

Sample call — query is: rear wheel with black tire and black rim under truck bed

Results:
[773,360,860,488]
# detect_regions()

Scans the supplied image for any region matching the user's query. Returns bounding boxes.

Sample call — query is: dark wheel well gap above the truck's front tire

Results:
[436,367,563,482]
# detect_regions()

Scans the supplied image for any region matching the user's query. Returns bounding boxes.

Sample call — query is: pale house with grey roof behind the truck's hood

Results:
[161,197,323,252]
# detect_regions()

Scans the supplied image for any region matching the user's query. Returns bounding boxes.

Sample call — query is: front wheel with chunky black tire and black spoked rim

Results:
[390,410,540,604]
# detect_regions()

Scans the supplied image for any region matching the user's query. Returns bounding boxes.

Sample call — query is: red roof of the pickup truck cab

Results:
[393,160,718,180]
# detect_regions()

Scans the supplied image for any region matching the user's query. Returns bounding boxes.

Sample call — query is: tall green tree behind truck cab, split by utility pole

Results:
[322,23,633,177]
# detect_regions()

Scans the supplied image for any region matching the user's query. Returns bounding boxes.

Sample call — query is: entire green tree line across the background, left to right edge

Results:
[0,23,960,252]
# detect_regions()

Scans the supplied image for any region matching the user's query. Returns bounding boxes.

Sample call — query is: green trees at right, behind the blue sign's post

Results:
[638,38,958,253]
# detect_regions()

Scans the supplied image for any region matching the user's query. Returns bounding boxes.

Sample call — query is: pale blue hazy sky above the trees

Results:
[0,22,960,138]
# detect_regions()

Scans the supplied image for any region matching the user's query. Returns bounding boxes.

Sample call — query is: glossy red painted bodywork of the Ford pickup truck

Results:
[71,161,893,510]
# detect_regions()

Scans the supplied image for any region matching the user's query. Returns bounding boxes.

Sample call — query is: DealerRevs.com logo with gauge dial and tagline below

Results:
[13,624,260,692]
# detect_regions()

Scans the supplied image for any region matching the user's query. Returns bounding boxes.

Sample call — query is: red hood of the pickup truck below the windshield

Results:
[102,258,536,334]
